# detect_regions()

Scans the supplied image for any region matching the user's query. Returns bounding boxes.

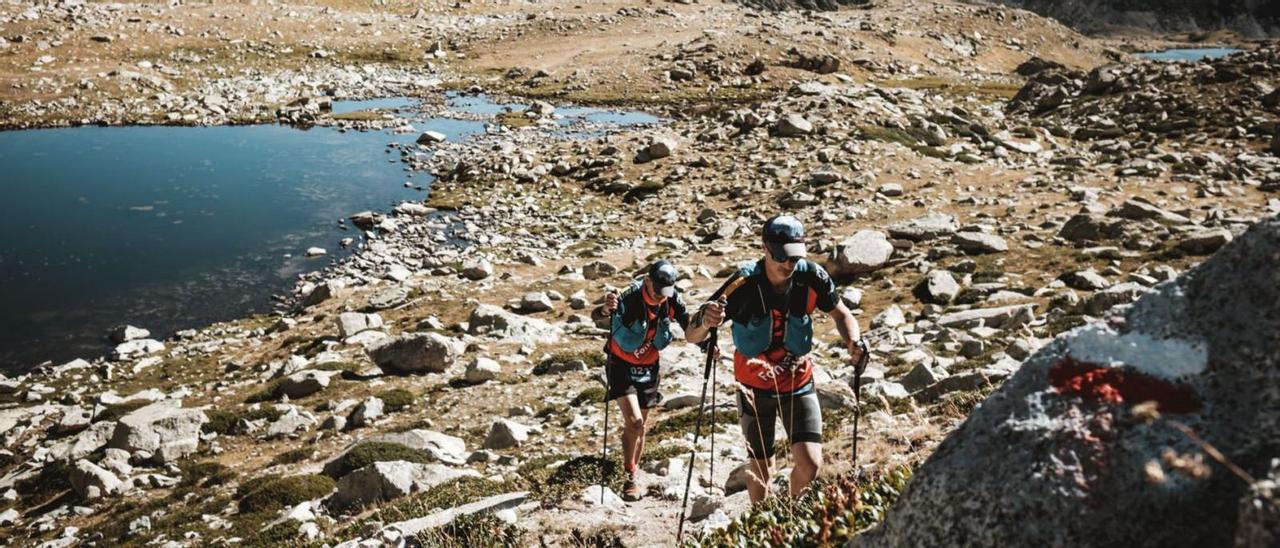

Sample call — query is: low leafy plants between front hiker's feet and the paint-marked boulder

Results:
[694,467,911,547]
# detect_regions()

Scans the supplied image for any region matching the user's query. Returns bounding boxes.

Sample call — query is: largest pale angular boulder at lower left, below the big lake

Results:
[108,399,209,462]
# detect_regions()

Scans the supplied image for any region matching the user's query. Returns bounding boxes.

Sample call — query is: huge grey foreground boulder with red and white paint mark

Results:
[850,213,1280,547]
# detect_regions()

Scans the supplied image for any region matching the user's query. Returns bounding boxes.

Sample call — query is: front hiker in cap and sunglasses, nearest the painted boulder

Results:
[687,215,863,502]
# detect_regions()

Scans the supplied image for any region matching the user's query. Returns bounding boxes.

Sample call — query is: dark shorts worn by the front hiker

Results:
[737,384,822,458]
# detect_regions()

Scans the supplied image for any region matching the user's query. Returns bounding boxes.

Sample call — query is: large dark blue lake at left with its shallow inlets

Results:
[0,96,657,370]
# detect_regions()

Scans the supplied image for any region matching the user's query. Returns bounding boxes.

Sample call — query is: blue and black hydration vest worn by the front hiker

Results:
[733,260,817,359]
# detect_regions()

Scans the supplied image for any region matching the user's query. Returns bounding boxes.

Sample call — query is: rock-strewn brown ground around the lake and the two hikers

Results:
[0,1,1280,545]
